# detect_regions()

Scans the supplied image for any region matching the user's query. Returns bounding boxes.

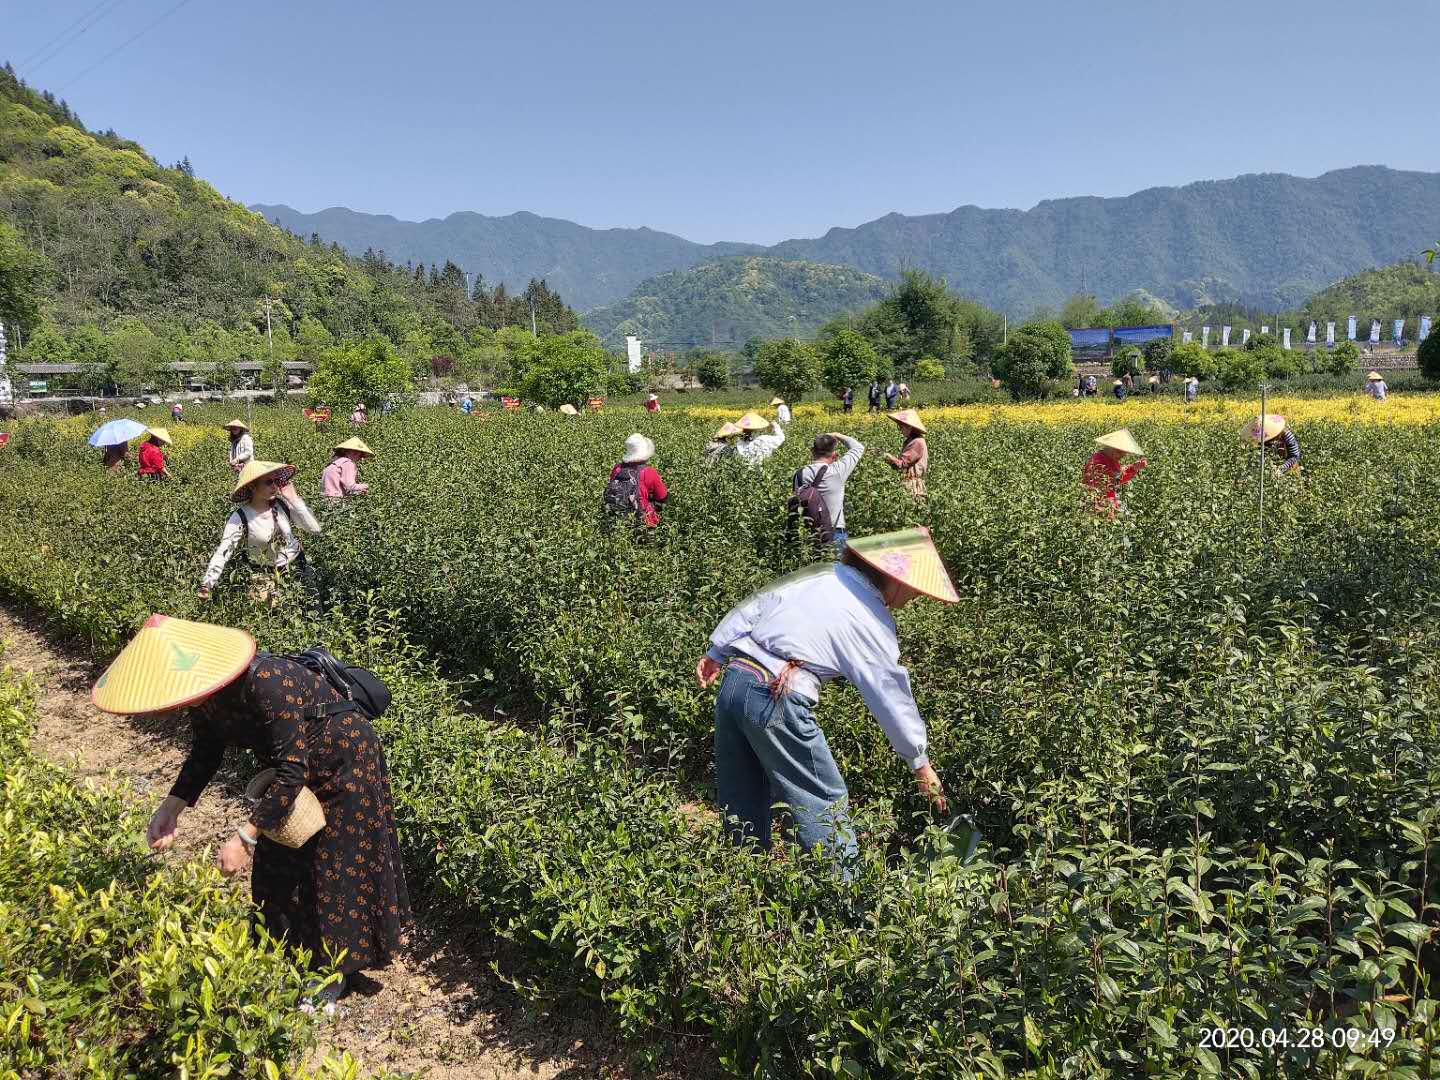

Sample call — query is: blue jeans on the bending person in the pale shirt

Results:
[716,664,857,877]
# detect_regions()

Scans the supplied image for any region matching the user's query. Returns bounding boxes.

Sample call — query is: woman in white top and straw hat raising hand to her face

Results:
[199,461,321,611]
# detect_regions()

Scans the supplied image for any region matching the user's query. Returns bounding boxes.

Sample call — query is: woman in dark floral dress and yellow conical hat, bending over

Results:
[91,615,410,1001]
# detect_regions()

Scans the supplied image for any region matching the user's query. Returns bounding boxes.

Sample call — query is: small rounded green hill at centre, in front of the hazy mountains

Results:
[583,255,886,346]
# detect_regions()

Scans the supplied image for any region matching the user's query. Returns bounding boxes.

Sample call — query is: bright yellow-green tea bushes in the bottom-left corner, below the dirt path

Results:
[0,656,397,1080]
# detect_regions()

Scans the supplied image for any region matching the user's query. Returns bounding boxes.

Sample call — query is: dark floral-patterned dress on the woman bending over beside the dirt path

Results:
[170,654,410,975]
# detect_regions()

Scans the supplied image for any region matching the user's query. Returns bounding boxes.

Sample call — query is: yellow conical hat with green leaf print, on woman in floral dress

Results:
[91,615,255,716]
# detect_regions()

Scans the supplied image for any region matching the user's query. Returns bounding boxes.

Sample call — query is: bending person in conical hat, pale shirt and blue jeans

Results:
[696,527,959,877]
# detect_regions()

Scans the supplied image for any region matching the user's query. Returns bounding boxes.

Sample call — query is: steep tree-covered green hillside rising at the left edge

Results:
[0,66,464,369]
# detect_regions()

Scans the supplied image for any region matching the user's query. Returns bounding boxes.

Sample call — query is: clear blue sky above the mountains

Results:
[11,0,1440,242]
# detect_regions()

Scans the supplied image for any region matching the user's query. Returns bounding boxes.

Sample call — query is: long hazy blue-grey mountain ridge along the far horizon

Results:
[252,166,1440,315]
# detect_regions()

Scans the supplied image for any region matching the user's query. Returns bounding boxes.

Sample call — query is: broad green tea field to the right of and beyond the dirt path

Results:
[0,395,1440,1077]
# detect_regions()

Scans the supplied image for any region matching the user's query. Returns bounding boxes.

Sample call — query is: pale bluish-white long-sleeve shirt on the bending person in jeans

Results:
[706,563,930,769]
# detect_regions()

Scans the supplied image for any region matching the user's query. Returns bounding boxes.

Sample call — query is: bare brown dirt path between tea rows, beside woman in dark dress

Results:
[0,605,702,1080]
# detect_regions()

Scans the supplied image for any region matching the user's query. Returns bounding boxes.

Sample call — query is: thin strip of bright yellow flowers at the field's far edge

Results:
[684,393,1440,426]
